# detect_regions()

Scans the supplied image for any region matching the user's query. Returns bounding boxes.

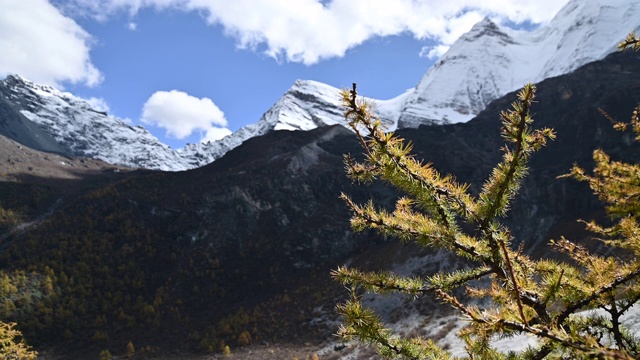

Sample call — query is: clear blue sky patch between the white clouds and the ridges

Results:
[67,9,434,147]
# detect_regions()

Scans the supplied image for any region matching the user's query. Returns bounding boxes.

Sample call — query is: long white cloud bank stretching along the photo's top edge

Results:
[63,0,568,64]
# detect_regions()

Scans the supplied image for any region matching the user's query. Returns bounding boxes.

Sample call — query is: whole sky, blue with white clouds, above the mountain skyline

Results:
[0,0,566,148]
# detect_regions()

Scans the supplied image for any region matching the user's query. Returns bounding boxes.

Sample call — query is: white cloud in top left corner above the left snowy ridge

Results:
[0,0,102,87]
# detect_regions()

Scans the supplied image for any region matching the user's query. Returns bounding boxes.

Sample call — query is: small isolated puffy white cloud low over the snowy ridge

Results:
[141,90,231,142]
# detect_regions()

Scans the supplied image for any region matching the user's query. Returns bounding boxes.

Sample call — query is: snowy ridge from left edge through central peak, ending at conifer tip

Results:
[0,75,356,171]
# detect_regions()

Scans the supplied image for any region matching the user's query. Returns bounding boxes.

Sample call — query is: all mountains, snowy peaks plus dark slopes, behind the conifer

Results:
[0,0,640,359]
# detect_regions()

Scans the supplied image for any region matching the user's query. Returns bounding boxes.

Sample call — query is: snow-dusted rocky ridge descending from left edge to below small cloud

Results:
[0,75,189,170]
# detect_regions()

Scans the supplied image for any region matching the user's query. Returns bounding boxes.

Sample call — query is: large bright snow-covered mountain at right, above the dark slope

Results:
[398,0,640,128]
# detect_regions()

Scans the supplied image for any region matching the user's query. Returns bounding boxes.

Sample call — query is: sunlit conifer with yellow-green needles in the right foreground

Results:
[333,34,640,359]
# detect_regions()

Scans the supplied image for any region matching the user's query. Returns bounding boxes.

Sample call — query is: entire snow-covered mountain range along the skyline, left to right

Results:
[0,0,640,171]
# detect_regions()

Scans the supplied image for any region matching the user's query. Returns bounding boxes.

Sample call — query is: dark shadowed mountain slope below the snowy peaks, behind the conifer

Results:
[0,52,640,358]
